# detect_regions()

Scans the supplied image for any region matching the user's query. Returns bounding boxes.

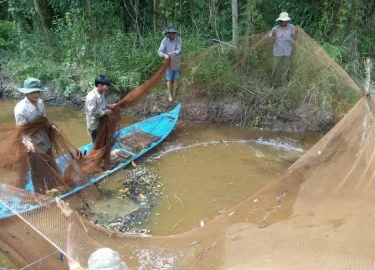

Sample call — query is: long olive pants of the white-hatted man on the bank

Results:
[271,56,292,86]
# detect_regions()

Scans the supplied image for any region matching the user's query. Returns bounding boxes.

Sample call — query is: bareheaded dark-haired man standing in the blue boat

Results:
[85,75,113,143]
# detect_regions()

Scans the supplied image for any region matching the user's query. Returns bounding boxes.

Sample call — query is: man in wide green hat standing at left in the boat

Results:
[14,78,60,194]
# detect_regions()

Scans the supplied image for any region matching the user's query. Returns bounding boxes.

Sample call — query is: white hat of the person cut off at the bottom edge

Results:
[87,248,128,270]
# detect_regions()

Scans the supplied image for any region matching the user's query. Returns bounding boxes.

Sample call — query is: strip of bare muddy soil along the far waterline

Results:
[0,73,335,134]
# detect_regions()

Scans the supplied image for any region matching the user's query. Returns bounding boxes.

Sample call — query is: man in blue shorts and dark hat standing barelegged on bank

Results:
[158,26,182,101]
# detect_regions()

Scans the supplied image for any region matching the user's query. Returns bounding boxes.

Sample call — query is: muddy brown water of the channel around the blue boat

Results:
[0,97,320,267]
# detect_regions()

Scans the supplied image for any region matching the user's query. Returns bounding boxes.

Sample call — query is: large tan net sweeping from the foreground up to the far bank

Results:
[0,29,375,269]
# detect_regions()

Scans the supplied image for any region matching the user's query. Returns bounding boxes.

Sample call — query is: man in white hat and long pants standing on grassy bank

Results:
[269,12,298,89]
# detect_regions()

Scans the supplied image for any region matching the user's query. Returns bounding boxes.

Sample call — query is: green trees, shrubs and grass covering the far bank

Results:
[0,0,375,130]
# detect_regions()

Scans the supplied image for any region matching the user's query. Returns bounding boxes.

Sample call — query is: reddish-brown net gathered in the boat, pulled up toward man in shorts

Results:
[0,61,170,194]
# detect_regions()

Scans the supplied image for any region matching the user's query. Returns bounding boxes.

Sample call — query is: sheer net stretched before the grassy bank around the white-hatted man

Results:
[182,27,360,128]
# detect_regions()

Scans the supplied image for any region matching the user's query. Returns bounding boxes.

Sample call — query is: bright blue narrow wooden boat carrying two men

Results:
[0,104,181,219]
